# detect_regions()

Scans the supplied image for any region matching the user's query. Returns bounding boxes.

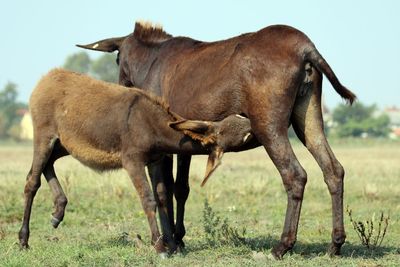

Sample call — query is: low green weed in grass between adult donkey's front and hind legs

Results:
[203,199,246,246]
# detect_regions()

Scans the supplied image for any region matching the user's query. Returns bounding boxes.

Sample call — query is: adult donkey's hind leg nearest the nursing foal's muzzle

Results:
[249,84,307,259]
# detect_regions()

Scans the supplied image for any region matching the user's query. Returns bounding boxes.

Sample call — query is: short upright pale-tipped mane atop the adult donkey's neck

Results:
[133,21,172,44]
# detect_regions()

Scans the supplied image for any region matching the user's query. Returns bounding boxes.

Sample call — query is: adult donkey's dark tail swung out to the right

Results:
[305,45,357,105]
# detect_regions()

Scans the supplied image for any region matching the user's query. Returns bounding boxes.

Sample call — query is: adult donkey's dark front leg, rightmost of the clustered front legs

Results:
[174,155,192,250]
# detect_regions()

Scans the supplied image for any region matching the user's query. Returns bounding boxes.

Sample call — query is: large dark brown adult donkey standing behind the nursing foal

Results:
[80,23,356,258]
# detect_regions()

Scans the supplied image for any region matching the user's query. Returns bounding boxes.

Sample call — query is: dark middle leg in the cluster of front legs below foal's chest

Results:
[148,155,176,253]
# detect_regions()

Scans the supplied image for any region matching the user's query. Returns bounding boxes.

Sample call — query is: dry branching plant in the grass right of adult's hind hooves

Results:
[346,207,390,249]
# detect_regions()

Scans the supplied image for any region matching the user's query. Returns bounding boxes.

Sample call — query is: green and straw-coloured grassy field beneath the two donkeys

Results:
[0,140,400,266]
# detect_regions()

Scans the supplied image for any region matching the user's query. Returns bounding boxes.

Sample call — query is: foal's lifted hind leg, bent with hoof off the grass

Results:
[43,140,69,228]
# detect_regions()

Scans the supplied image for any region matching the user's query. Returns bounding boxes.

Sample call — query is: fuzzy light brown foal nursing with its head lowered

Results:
[19,69,251,255]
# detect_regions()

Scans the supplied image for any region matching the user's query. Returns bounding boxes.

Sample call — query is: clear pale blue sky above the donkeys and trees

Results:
[0,0,400,107]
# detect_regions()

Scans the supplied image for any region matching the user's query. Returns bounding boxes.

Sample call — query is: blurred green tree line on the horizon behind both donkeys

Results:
[0,51,390,139]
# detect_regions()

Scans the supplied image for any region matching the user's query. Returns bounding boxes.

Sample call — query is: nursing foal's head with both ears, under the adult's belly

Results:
[169,115,252,186]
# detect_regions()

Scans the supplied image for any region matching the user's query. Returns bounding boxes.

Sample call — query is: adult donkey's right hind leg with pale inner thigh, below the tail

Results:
[291,69,346,255]
